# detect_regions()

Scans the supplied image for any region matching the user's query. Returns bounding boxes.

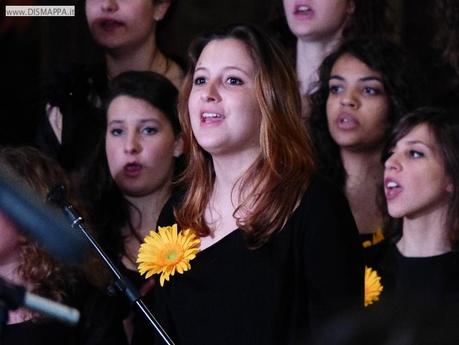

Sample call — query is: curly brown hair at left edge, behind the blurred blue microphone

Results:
[0,147,82,301]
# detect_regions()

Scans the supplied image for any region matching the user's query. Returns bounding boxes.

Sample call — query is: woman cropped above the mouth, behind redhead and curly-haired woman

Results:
[283,0,389,117]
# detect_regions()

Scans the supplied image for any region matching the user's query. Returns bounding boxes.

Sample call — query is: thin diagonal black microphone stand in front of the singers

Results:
[48,185,174,345]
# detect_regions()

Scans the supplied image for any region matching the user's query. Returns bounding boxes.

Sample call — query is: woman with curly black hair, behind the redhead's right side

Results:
[310,39,421,245]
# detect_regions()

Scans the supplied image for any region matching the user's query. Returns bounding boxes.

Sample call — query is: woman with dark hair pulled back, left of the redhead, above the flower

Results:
[82,72,182,338]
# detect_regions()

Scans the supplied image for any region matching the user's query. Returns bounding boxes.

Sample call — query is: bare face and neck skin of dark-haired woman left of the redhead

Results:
[105,96,183,270]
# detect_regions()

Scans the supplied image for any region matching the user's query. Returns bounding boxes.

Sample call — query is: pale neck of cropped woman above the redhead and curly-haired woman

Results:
[296,34,341,95]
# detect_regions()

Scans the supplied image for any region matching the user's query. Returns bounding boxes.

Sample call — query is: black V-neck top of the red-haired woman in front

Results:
[154,176,363,345]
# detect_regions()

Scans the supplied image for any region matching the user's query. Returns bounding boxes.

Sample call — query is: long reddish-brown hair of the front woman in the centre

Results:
[176,25,315,247]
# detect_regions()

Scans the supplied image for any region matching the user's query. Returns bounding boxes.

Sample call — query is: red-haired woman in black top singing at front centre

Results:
[139,25,363,345]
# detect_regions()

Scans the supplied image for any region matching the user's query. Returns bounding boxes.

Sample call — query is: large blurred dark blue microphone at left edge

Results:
[0,167,86,263]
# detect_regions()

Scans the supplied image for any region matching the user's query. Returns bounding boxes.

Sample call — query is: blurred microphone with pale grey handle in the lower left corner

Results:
[0,278,80,325]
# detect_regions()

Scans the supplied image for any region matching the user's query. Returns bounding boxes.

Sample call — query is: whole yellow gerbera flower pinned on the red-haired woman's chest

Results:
[137,224,201,286]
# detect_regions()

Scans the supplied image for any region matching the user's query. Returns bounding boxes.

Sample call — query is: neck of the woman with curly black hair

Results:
[341,150,384,187]
